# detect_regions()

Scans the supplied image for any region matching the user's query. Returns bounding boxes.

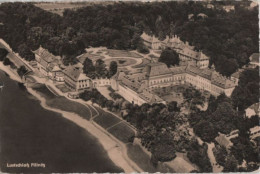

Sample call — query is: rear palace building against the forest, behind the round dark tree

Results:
[141,33,209,69]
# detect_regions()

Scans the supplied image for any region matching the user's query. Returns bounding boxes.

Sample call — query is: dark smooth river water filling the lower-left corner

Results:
[0,70,123,173]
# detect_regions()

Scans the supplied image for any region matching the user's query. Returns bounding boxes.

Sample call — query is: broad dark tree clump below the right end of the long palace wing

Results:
[190,94,242,142]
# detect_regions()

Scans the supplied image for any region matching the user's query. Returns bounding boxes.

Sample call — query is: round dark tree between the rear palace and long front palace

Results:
[158,49,180,67]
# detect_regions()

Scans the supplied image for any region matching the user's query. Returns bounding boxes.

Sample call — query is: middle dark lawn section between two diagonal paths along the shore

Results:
[94,108,121,129]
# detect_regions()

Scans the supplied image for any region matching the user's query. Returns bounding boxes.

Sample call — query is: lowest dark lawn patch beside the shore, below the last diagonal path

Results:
[108,123,135,143]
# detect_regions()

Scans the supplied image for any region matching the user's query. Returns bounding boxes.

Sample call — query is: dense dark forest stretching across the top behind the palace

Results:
[0,1,259,76]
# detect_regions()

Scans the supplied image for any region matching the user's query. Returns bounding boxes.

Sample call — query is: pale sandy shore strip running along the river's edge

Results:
[0,62,142,173]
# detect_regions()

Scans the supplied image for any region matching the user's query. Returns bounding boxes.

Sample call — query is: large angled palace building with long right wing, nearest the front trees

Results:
[111,62,237,105]
